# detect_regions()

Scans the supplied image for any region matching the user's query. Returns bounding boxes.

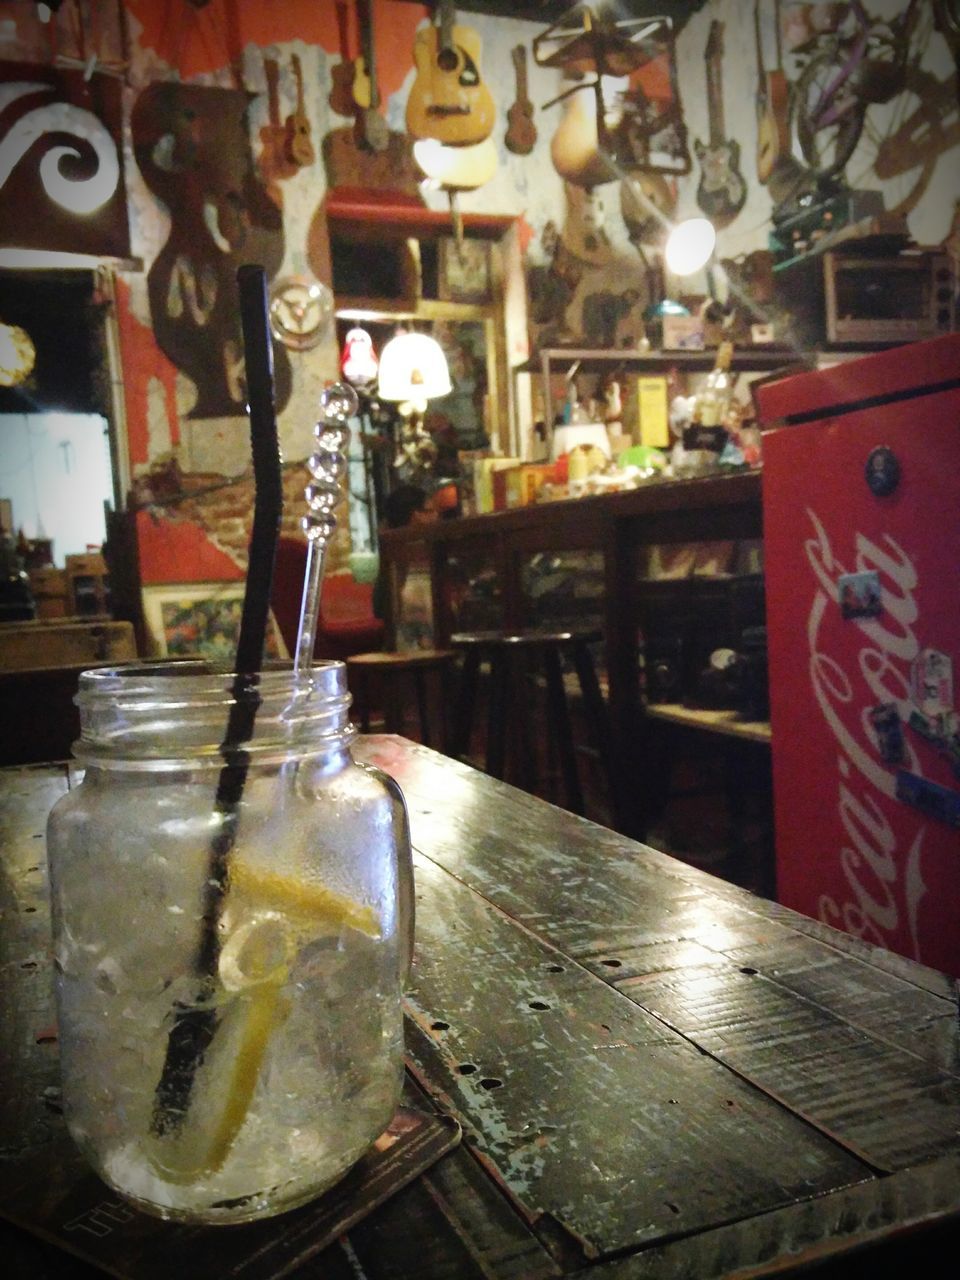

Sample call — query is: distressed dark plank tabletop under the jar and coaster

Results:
[0,735,960,1280]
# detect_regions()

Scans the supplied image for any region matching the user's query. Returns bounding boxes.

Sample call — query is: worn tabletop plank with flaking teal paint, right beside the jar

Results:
[407,858,869,1254]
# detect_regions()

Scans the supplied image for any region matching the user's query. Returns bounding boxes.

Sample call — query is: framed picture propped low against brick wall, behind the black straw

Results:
[143,582,289,663]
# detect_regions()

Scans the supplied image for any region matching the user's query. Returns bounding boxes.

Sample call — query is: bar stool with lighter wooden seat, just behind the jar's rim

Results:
[344,649,460,751]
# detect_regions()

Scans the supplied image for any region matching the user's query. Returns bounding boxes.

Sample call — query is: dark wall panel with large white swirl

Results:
[0,63,131,257]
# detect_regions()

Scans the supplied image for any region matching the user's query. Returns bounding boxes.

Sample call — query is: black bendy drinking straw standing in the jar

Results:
[151,264,283,1135]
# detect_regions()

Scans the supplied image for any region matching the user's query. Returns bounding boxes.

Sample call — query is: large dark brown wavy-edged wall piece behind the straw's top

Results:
[131,81,291,419]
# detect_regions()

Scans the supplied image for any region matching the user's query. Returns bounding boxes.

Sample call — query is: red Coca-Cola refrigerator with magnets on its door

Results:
[755,334,960,977]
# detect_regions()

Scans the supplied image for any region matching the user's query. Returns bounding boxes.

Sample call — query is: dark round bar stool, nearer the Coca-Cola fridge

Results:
[449,627,620,822]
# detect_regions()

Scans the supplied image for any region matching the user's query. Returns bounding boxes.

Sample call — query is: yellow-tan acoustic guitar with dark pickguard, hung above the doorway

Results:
[407,0,495,146]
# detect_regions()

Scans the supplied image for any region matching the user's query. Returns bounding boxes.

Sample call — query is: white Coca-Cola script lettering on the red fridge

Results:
[804,507,927,959]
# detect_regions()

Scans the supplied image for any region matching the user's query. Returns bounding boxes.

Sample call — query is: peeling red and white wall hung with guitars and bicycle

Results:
[0,0,960,586]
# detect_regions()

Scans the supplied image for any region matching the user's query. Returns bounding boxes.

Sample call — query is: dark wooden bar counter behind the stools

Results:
[380,471,763,838]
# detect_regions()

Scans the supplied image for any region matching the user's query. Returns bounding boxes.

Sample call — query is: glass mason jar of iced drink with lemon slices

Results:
[47,662,413,1222]
